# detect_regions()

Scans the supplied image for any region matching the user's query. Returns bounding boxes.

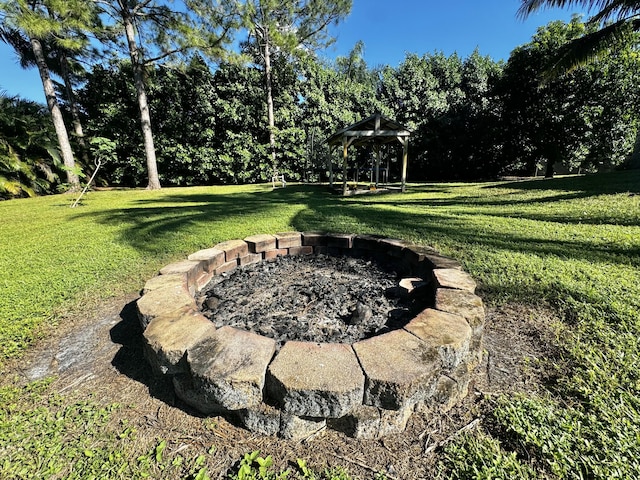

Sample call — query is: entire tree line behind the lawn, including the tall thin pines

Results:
[0,0,640,198]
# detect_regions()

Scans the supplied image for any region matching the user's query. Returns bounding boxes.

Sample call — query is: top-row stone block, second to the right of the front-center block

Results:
[404,308,472,370]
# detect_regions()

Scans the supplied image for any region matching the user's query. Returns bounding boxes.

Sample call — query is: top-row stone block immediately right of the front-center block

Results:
[353,330,441,410]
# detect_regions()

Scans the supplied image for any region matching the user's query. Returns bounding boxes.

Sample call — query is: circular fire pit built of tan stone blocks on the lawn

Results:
[137,232,484,438]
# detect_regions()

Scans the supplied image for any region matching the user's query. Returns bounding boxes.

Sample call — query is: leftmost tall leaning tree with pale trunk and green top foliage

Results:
[0,0,94,190]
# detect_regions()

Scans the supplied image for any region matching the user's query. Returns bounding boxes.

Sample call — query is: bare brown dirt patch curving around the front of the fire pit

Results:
[4,295,560,479]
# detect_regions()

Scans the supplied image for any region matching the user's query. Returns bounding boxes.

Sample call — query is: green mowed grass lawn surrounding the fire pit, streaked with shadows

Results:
[0,171,640,478]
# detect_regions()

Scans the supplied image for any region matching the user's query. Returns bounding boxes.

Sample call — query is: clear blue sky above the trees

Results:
[0,0,586,102]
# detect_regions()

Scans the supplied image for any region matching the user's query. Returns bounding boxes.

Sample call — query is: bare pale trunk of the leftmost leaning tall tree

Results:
[29,38,80,192]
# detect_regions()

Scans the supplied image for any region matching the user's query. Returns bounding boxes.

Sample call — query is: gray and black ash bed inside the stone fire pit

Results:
[197,255,412,346]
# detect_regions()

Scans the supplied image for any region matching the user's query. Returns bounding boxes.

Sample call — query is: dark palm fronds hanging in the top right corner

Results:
[518,0,640,78]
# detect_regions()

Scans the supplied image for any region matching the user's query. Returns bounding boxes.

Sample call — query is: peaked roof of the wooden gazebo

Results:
[326,113,411,146]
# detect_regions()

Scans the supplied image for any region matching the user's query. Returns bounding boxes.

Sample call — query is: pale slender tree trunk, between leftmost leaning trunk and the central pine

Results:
[122,8,160,190]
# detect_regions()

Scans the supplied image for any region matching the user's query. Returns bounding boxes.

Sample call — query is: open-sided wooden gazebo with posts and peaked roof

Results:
[326,113,411,195]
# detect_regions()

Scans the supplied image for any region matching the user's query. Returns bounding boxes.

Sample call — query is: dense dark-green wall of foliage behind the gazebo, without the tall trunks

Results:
[0,18,640,197]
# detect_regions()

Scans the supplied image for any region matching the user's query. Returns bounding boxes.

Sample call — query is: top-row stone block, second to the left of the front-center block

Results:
[143,310,216,375]
